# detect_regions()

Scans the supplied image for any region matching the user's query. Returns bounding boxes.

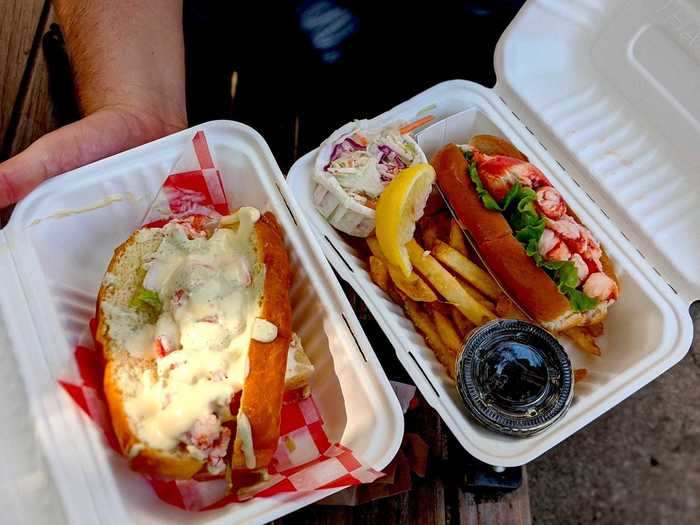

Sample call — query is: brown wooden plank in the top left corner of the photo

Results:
[0,0,47,152]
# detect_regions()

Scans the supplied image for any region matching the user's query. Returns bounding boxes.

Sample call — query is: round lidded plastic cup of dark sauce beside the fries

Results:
[457,319,573,436]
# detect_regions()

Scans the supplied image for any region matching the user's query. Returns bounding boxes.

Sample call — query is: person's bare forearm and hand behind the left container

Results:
[0,0,187,209]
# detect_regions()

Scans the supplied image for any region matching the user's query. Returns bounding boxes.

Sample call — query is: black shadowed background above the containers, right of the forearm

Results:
[185,0,523,171]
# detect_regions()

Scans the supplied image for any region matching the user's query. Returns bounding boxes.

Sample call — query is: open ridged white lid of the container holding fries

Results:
[495,0,700,303]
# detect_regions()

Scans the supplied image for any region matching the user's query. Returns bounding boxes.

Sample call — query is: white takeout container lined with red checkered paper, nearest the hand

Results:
[0,121,403,524]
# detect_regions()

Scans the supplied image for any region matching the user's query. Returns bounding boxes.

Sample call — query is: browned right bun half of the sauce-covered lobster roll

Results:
[233,212,292,469]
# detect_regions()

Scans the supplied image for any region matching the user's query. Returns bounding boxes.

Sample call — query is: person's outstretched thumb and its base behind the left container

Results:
[0,109,178,209]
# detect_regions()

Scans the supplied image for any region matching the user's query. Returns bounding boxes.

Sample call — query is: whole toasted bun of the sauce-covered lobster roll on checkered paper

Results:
[96,213,304,479]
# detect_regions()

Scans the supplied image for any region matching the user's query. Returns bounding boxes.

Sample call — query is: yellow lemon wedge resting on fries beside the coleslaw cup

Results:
[376,163,435,277]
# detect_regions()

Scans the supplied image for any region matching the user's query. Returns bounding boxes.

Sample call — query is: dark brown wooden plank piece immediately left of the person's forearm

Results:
[9,7,58,155]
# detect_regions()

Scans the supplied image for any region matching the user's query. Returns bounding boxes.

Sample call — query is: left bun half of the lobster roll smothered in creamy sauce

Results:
[96,230,204,479]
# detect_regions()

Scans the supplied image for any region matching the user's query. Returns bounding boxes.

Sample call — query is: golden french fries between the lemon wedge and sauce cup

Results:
[367,212,602,381]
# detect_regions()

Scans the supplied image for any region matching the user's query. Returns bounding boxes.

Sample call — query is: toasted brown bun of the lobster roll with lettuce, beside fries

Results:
[431,144,617,332]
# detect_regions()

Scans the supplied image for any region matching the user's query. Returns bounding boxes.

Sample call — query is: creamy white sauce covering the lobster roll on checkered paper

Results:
[112,208,264,450]
